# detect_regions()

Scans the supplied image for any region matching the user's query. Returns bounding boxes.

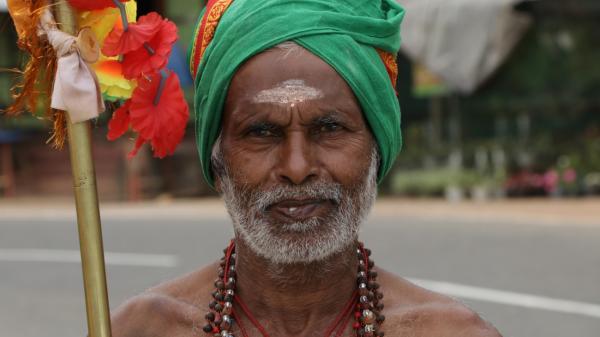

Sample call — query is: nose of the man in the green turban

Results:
[275,131,319,185]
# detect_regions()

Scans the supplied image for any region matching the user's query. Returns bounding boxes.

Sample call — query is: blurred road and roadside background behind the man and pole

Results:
[0,0,600,337]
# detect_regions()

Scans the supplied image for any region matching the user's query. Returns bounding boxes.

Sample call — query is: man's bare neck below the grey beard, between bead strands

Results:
[236,238,357,336]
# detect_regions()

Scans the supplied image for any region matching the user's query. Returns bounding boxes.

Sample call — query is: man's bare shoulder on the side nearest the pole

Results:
[111,265,214,337]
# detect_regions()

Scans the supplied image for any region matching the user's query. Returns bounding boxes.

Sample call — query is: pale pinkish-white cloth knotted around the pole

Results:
[38,10,106,123]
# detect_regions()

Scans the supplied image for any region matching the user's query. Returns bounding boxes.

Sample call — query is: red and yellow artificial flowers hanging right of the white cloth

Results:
[69,0,189,158]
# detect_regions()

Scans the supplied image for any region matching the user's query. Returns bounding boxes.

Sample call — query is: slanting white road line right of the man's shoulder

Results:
[408,278,600,318]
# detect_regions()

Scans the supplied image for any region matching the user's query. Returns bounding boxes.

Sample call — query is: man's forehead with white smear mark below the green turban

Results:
[225,46,360,114]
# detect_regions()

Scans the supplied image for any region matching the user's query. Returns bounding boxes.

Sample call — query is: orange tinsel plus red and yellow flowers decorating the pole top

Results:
[7,0,189,158]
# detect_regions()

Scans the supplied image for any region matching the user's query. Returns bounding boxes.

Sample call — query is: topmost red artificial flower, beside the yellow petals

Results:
[102,12,164,56]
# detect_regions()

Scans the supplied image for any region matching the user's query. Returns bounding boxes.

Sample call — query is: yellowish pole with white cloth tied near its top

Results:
[55,0,111,337]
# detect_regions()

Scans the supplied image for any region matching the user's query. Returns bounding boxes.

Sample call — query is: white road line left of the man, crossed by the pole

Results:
[0,249,179,268]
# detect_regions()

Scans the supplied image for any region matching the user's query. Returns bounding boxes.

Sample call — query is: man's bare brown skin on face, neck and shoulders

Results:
[112,45,500,337]
